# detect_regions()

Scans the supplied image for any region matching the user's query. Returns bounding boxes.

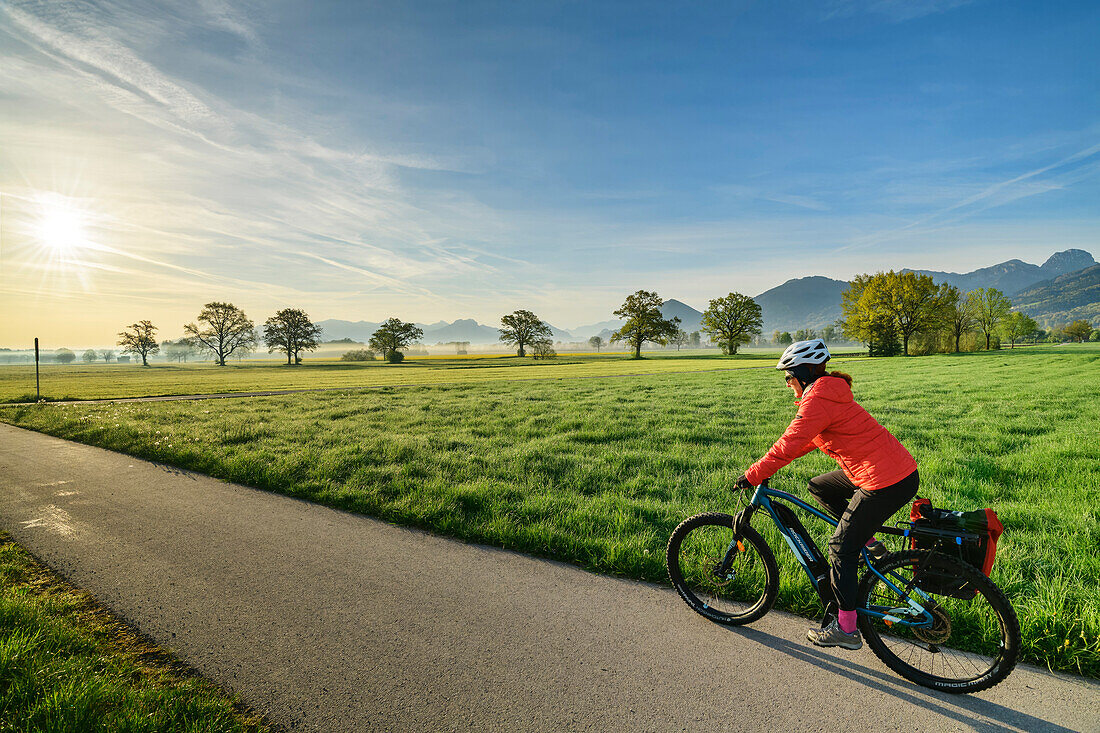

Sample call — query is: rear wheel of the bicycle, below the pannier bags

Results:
[859,550,1020,692]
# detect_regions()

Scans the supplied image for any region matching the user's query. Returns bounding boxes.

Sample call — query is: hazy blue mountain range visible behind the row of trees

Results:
[318,250,1100,344]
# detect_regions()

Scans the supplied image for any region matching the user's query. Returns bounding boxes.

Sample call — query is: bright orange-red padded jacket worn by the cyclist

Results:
[745,376,916,491]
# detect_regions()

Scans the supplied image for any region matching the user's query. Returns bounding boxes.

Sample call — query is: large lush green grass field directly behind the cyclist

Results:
[0,347,1100,677]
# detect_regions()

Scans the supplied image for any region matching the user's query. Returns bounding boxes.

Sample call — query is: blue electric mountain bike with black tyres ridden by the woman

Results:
[667,482,1020,693]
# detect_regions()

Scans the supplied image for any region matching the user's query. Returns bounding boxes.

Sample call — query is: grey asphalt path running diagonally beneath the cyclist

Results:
[0,425,1100,733]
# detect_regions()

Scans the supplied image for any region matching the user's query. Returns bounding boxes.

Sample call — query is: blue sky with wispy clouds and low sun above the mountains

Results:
[0,0,1100,344]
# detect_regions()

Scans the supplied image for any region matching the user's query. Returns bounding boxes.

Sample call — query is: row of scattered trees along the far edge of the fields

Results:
[103,283,1100,367]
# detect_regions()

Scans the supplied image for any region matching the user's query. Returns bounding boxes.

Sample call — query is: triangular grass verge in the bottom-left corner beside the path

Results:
[0,533,270,733]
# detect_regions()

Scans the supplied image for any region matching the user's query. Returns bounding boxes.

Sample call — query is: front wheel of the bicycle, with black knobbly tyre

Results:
[667,514,779,626]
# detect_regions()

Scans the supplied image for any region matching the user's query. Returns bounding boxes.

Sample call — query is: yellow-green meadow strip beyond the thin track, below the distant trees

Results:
[0,351,805,403]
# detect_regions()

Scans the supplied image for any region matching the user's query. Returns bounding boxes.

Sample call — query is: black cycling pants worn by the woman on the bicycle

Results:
[810,471,921,611]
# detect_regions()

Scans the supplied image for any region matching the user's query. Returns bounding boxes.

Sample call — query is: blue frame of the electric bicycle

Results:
[726,483,935,626]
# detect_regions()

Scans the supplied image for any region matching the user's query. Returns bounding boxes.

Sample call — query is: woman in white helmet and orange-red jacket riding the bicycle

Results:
[736,339,920,649]
